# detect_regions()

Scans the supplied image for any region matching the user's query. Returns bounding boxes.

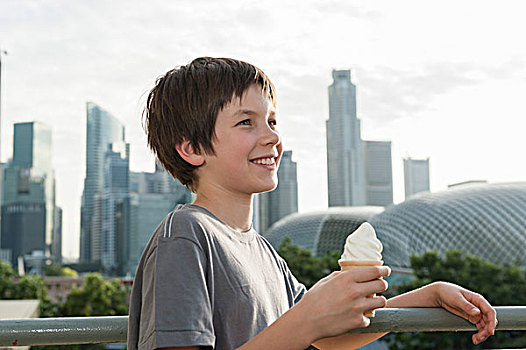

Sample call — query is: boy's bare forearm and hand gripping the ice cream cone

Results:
[240,266,390,350]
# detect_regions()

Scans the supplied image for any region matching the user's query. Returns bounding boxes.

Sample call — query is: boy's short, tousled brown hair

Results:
[143,57,276,192]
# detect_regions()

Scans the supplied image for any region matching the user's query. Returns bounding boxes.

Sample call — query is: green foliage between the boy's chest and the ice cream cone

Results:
[279,237,340,289]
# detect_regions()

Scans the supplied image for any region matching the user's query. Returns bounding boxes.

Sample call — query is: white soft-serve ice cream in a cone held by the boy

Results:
[338,222,383,317]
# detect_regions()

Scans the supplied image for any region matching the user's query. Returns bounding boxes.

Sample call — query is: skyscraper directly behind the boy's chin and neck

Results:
[255,151,298,234]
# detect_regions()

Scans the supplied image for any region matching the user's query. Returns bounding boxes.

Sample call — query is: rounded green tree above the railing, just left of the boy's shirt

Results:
[62,273,128,316]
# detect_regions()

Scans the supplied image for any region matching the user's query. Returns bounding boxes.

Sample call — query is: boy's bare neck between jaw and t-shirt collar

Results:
[193,185,253,232]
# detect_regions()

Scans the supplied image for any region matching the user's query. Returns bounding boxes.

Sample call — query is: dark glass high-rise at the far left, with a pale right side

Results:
[1,122,62,262]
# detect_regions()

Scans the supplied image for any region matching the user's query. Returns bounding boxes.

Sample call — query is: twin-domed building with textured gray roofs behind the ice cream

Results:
[265,183,526,268]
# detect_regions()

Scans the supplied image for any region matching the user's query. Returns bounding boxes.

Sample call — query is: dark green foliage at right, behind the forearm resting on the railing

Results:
[386,250,526,350]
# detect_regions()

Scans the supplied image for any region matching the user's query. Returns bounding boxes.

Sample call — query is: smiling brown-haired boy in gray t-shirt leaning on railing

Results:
[128,57,496,349]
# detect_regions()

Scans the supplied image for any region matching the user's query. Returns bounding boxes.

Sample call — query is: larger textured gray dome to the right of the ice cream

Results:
[370,183,526,267]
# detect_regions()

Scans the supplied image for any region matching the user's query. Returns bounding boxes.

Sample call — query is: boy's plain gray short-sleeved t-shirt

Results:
[128,205,306,350]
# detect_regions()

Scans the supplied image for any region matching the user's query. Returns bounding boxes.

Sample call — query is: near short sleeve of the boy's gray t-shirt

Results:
[140,232,215,349]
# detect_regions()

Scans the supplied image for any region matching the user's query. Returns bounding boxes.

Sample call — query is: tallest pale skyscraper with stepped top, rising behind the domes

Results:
[326,70,366,207]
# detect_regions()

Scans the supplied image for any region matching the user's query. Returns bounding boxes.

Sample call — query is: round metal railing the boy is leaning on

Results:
[0,306,526,346]
